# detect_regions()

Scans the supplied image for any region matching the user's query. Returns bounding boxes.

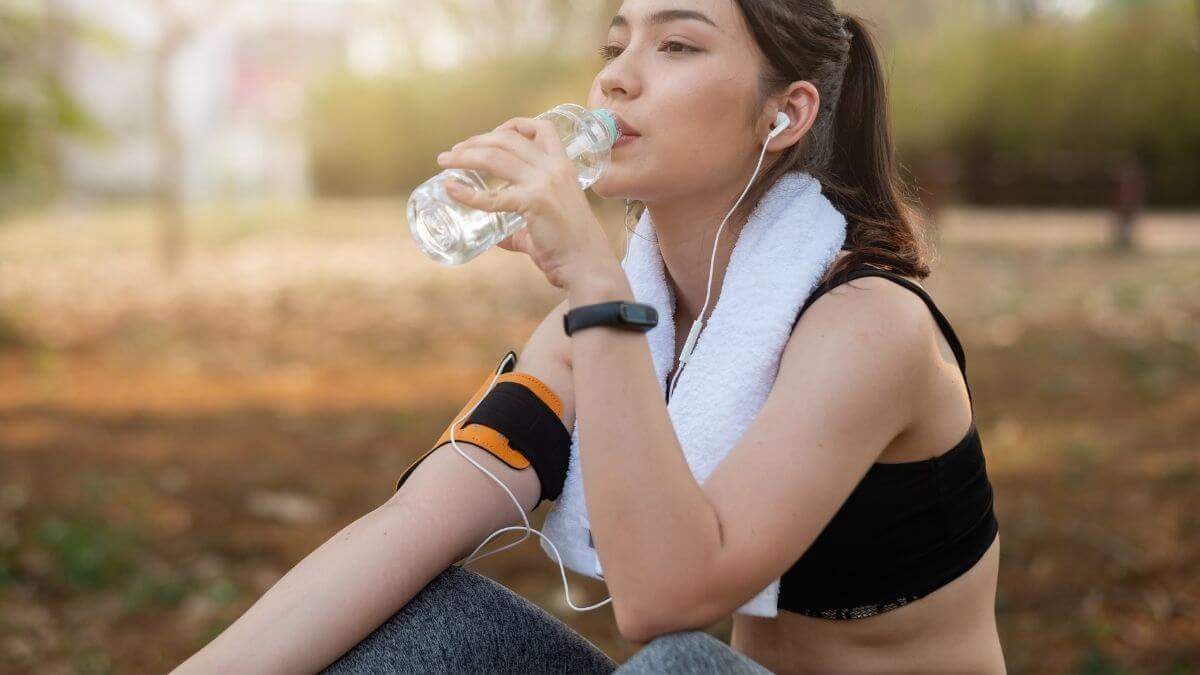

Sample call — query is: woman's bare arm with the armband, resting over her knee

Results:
[174,300,574,675]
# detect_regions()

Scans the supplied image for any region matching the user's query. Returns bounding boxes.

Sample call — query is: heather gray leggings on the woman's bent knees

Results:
[322,565,770,675]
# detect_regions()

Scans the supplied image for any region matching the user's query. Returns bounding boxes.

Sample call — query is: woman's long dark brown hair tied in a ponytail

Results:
[624,0,930,283]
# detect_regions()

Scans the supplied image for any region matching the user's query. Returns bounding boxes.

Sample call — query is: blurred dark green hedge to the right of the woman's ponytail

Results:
[892,0,1200,205]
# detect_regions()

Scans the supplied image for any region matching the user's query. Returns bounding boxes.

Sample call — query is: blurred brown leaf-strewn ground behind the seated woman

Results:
[0,202,1200,674]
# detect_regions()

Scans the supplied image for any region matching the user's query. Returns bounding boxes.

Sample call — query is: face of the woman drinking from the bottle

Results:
[588,0,769,203]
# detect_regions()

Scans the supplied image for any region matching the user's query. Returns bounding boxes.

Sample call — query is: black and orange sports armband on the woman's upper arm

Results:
[396,351,571,507]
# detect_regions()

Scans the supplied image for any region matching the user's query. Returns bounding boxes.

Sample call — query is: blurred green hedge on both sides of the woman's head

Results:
[307,0,1200,205]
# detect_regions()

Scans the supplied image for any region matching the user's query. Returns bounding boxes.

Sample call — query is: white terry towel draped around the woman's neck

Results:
[539,172,846,617]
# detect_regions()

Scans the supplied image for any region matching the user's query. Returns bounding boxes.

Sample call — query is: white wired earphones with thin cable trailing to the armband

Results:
[450,112,792,611]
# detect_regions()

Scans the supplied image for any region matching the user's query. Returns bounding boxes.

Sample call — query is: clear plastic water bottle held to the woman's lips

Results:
[408,103,620,265]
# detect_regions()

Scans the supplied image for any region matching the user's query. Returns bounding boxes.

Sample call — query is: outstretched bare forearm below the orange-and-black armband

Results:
[175,500,460,674]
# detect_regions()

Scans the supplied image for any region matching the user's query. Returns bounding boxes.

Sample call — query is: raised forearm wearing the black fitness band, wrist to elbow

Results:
[568,265,721,622]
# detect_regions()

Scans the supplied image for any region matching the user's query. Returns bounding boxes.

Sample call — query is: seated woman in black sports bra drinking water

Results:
[178,0,1004,673]
